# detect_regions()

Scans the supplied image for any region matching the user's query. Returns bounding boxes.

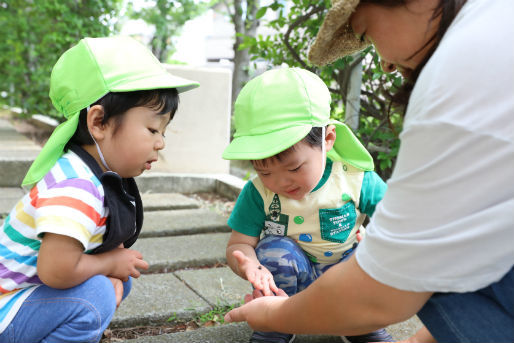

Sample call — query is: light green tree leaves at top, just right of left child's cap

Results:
[129,0,215,63]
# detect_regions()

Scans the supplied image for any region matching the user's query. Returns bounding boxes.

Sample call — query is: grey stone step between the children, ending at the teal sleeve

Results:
[141,208,230,237]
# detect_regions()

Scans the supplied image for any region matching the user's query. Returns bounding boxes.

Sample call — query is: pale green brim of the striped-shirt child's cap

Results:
[110,72,200,93]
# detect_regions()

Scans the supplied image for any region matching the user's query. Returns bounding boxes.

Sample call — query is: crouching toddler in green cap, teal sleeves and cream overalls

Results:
[223,68,392,343]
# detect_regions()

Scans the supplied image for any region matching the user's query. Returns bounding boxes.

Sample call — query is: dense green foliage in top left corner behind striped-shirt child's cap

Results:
[0,0,121,117]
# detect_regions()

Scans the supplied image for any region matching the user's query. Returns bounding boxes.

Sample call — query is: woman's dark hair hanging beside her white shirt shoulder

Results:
[360,0,467,110]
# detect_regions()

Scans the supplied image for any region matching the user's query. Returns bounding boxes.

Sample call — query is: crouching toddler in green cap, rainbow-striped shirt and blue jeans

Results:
[0,37,198,342]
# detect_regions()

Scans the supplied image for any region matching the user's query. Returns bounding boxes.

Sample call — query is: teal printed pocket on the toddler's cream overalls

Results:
[319,201,357,243]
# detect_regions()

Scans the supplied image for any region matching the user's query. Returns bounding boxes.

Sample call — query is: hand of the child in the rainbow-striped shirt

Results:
[105,247,148,282]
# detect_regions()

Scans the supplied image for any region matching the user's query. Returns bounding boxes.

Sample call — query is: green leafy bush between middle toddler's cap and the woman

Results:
[239,0,402,178]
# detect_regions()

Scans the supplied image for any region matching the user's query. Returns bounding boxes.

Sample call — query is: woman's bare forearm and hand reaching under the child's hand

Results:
[225,256,431,335]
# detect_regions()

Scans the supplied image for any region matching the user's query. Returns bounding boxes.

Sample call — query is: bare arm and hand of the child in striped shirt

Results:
[37,233,148,288]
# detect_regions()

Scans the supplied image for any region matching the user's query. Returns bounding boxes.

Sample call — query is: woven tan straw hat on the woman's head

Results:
[309,0,370,66]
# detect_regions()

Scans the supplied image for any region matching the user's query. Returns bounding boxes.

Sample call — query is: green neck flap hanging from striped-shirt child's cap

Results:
[21,112,80,186]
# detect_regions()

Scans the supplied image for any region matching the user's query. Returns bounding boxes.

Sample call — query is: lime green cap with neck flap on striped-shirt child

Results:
[22,36,199,186]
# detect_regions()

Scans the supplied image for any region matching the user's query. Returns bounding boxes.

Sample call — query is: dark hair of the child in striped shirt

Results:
[65,88,179,150]
